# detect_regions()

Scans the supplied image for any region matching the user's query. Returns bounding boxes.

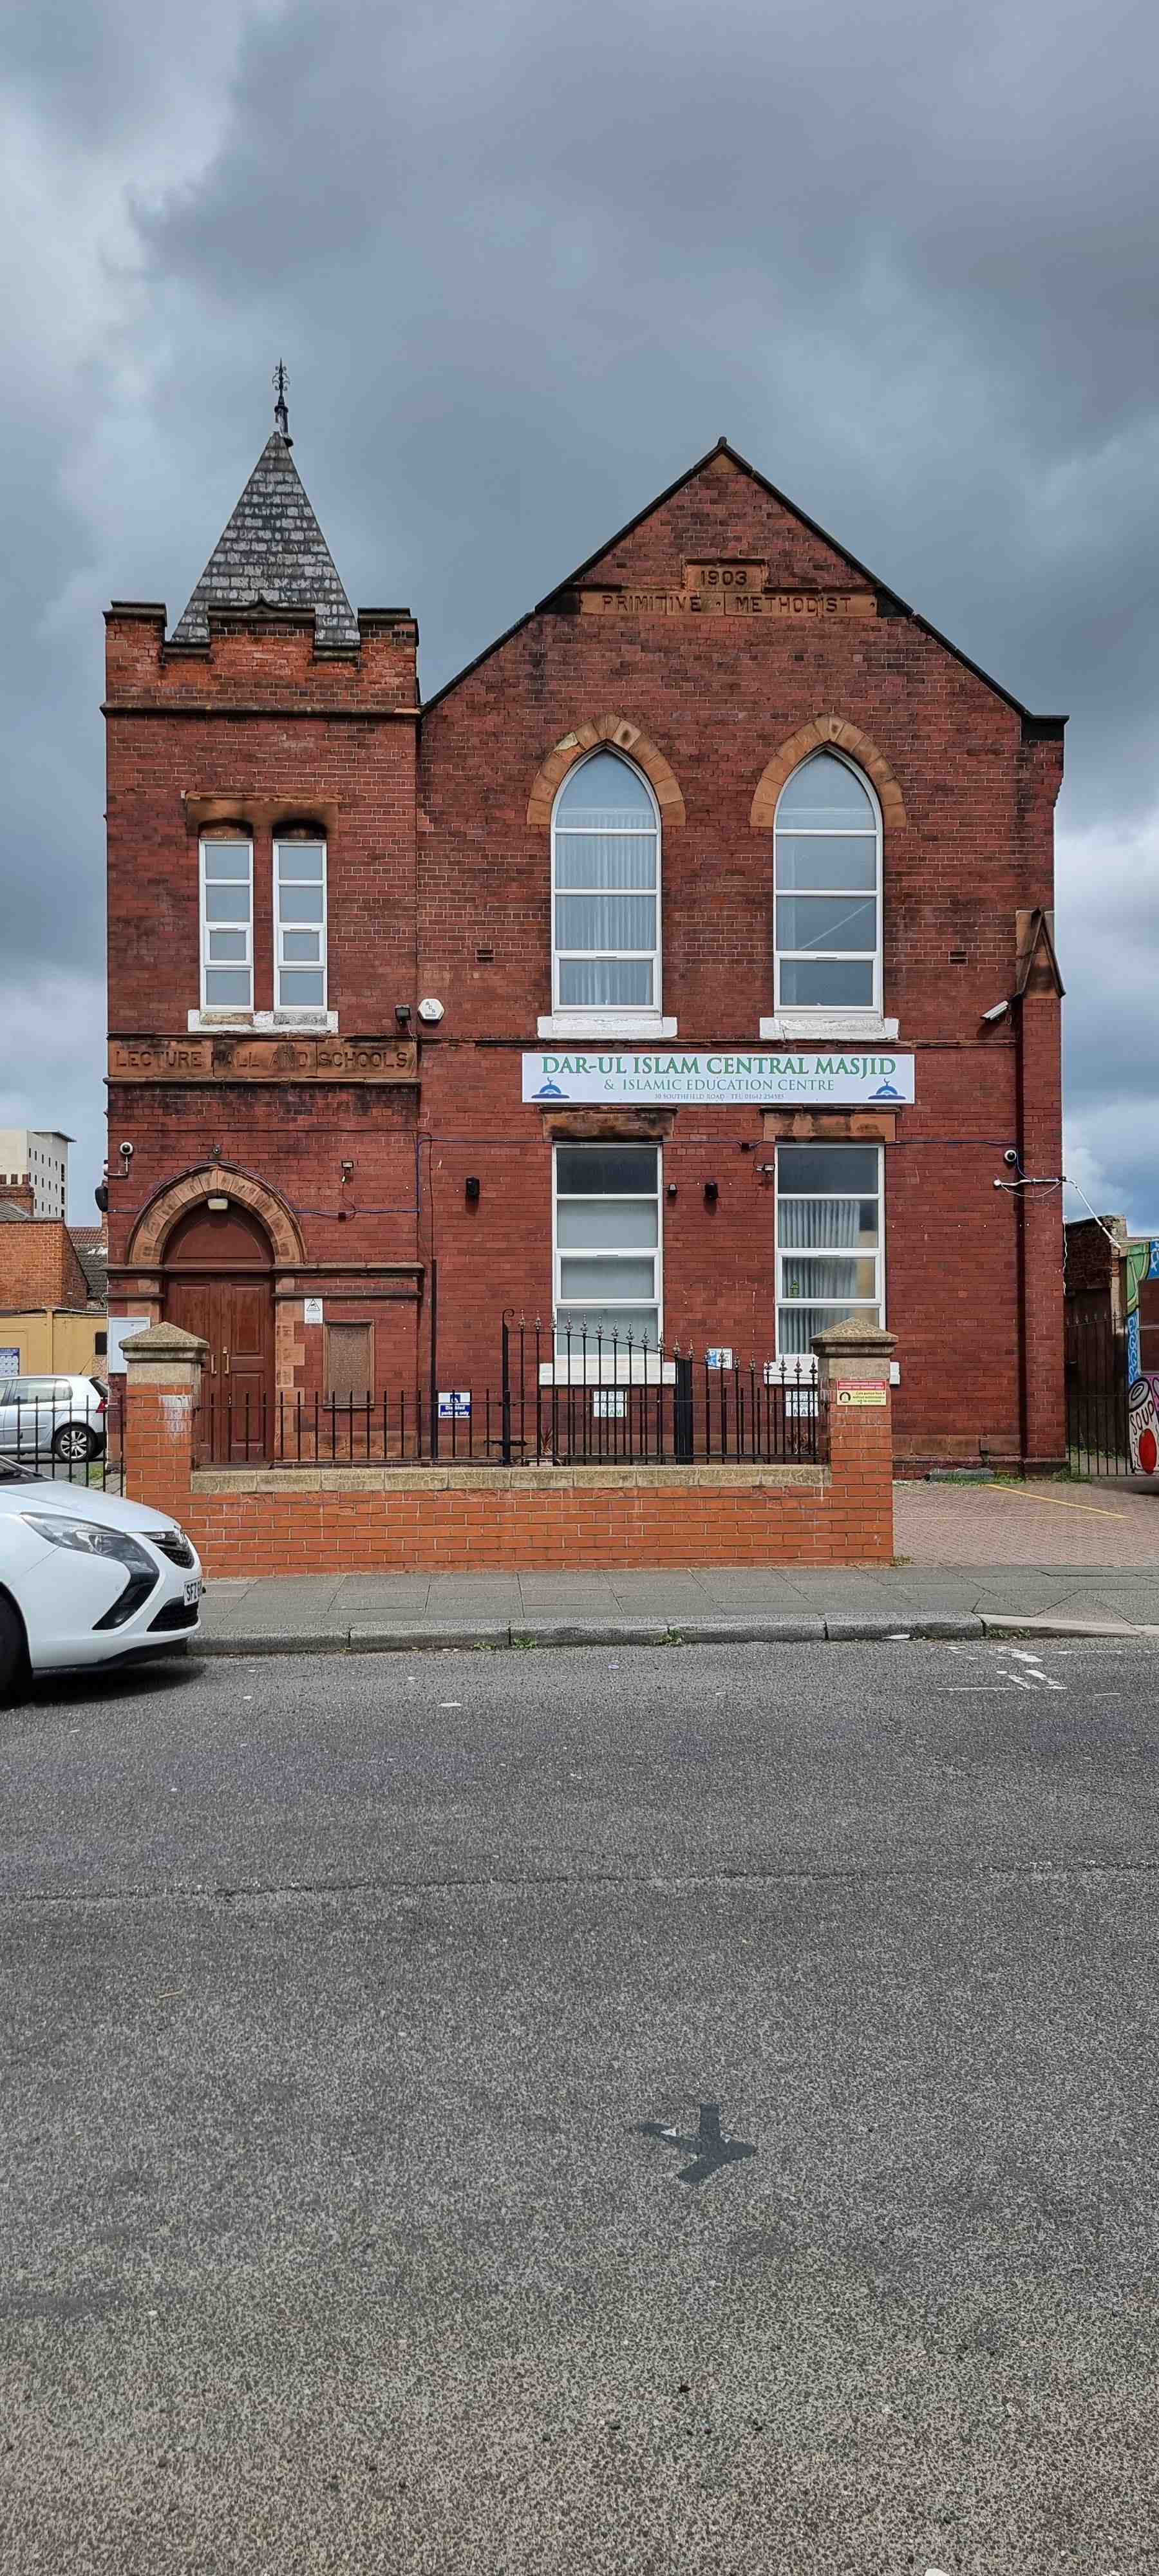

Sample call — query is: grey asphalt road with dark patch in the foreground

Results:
[0,1643,1159,2576]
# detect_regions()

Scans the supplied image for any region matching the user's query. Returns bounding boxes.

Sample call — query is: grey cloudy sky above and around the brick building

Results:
[0,0,1159,1229]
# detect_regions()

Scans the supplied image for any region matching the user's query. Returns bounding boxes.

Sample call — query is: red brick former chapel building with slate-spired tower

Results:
[106,392,1064,1466]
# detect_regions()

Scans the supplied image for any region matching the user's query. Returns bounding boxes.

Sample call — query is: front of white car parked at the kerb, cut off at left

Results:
[0,1458,201,1700]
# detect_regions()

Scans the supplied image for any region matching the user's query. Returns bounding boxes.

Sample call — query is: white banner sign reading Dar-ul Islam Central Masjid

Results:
[523,1046,914,1108]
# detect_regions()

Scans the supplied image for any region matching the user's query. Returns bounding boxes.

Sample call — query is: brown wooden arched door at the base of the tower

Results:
[162,1193,273,1466]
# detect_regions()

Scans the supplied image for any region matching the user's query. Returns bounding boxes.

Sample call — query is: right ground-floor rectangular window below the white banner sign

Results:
[778,1144,886,1360]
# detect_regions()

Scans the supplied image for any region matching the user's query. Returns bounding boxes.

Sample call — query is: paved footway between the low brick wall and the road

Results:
[203,1484,1159,1654]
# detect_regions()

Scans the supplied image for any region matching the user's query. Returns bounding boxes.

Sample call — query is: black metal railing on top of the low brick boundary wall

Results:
[198,1314,827,1468]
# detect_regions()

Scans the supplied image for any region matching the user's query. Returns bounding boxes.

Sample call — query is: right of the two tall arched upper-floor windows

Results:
[775,752,881,1012]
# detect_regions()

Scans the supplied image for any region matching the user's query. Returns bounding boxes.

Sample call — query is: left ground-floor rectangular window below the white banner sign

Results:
[554,1144,662,1376]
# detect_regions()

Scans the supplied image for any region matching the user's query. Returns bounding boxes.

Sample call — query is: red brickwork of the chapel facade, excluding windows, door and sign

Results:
[104,428,1064,1468]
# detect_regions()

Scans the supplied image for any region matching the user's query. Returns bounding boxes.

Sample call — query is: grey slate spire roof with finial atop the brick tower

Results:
[173,386,358,649]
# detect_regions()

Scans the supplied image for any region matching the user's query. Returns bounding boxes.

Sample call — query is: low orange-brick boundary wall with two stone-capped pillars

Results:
[126,1324,894,1577]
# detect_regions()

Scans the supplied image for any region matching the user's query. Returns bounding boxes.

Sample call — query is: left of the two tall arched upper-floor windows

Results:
[551,750,659,1012]
